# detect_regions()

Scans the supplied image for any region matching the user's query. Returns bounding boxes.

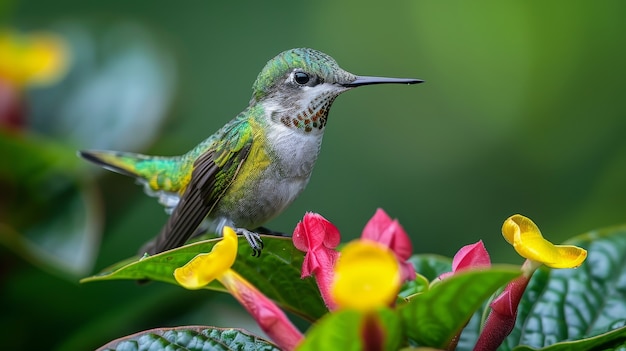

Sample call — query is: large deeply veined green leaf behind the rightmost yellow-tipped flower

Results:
[499,226,626,350]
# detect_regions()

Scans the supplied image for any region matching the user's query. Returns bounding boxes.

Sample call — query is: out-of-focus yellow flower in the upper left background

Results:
[0,29,70,87]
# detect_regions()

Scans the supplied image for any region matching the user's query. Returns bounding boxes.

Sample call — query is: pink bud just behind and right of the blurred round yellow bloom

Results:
[361,208,415,281]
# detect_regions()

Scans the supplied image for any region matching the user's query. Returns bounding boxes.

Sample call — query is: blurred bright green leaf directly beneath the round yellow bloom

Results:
[298,308,402,351]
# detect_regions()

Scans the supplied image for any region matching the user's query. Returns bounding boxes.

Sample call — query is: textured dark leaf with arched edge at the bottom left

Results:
[98,326,280,351]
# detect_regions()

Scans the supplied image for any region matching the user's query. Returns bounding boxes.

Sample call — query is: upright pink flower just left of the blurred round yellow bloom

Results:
[292,212,341,309]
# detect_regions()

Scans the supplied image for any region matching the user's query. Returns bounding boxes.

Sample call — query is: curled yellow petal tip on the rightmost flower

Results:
[502,214,587,268]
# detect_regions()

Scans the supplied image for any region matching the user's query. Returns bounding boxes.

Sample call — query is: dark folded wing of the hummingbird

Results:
[140,124,253,254]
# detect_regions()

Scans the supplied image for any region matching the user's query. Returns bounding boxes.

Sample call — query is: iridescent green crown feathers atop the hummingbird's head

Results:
[252,48,350,101]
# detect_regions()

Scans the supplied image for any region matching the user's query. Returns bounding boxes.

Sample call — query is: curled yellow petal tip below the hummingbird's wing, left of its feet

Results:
[174,227,238,289]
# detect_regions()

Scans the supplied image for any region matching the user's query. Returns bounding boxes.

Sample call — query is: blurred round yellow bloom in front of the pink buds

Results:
[331,240,400,311]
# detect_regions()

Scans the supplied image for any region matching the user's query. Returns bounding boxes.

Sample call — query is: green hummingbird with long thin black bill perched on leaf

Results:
[79,48,423,256]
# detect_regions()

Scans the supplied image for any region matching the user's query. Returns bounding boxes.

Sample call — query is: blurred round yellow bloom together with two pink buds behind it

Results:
[293,209,415,310]
